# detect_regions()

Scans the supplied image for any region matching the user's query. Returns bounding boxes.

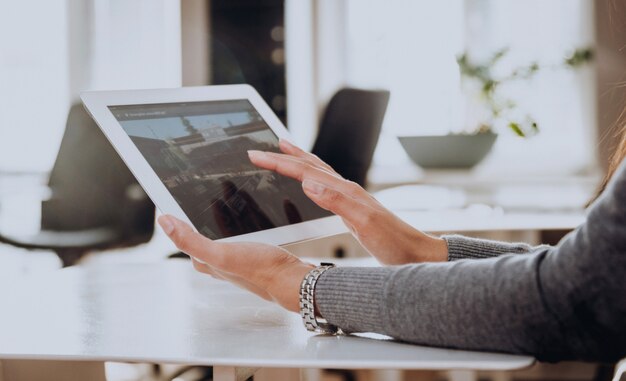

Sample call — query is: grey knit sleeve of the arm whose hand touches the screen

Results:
[441,235,535,261]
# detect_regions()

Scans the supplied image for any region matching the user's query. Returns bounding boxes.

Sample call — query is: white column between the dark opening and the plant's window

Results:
[285,0,346,149]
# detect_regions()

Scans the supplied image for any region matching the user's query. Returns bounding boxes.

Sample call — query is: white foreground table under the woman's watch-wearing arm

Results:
[0,260,534,379]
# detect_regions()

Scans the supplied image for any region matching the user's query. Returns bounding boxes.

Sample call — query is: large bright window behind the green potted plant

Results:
[346,0,595,175]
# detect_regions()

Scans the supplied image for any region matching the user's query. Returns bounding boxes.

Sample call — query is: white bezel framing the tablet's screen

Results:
[81,85,347,245]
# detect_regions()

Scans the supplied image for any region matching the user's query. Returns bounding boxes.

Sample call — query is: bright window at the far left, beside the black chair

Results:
[0,0,69,172]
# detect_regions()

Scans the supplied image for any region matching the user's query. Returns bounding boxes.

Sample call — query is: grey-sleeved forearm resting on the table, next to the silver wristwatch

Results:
[316,253,574,359]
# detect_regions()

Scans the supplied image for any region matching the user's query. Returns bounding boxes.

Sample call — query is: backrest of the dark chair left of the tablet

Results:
[41,104,154,246]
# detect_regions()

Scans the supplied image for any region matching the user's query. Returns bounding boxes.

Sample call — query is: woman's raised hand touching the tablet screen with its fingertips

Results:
[248,140,448,265]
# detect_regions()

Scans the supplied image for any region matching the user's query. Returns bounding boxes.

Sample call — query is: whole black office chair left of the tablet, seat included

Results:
[0,105,154,266]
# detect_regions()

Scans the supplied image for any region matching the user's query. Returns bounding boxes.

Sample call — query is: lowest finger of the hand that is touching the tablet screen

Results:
[302,179,378,229]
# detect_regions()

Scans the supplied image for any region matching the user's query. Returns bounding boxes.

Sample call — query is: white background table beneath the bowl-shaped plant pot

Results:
[375,184,593,232]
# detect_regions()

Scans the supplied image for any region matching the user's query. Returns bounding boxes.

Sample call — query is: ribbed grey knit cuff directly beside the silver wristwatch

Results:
[315,267,391,332]
